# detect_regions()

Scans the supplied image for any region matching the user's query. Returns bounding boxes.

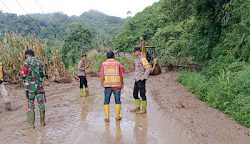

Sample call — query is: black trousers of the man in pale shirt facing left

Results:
[133,80,147,101]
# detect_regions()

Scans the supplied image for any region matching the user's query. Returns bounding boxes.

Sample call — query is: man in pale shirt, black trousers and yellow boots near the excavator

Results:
[130,47,151,114]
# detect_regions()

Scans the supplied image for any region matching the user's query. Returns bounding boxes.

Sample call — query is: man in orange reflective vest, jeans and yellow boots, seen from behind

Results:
[101,50,124,122]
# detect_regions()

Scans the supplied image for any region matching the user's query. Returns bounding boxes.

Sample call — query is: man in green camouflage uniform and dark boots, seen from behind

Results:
[21,50,46,128]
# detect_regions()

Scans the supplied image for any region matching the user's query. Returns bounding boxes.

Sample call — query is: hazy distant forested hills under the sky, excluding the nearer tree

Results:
[0,10,125,46]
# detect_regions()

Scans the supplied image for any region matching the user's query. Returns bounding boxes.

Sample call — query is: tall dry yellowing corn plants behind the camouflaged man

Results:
[0,34,68,84]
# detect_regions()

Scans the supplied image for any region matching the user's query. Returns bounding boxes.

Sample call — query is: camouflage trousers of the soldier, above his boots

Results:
[26,90,46,112]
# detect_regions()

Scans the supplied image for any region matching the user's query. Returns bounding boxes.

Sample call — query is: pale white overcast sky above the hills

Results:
[0,0,159,17]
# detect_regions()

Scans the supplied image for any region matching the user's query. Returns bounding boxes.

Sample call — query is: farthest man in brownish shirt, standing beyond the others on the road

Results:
[78,55,89,97]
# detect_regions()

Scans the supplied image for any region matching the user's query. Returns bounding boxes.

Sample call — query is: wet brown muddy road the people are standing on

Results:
[0,72,250,144]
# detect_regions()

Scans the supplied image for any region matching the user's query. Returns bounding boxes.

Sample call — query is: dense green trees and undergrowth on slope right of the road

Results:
[114,0,250,127]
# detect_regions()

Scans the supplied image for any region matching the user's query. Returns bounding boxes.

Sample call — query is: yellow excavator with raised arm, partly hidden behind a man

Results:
[136,35,161,75]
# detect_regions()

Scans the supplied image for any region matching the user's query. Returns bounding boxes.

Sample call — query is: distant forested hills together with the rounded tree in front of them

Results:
[0,10,126,69]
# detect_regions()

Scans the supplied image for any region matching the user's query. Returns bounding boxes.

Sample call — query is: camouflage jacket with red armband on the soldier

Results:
[21,57,45,91]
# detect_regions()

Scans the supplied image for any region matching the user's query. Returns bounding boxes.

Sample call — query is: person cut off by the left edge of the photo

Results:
[0,62,11,110]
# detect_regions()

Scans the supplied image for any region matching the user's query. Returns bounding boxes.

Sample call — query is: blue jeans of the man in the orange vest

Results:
[104,87,121,105]
